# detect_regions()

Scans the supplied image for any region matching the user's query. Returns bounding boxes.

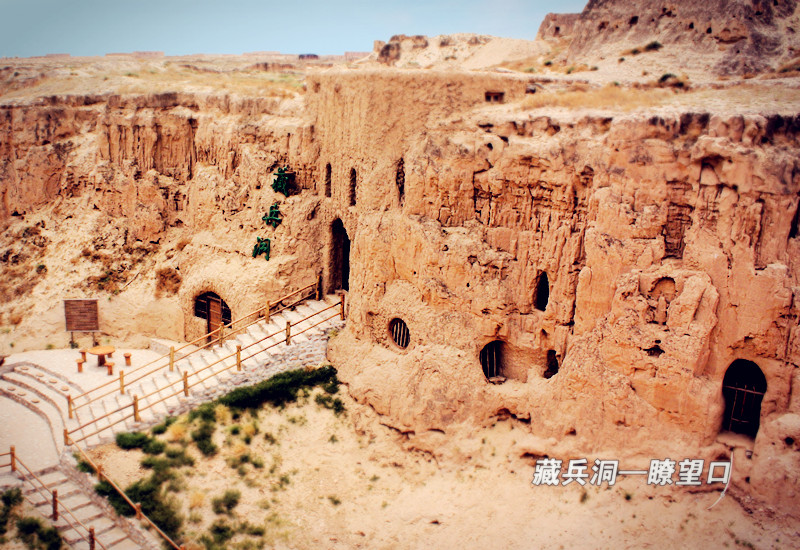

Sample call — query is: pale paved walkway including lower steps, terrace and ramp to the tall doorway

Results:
[0,296,343,550]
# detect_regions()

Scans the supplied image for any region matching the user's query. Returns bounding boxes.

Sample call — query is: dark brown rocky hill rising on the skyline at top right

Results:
[539,0,800,75]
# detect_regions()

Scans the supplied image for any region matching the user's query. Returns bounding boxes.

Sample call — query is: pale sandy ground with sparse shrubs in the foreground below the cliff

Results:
[87,387,800,549]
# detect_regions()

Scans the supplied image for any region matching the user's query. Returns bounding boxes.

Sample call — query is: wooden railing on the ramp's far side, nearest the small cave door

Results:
[67,281,322,418]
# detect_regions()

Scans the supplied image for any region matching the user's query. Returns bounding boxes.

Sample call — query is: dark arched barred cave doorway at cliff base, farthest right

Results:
[722,359,767,438]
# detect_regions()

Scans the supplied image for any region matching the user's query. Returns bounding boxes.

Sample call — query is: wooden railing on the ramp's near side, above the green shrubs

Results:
[64,297,345,445]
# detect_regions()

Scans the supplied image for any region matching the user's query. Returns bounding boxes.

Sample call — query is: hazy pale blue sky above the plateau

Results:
[0,0,586,57]
